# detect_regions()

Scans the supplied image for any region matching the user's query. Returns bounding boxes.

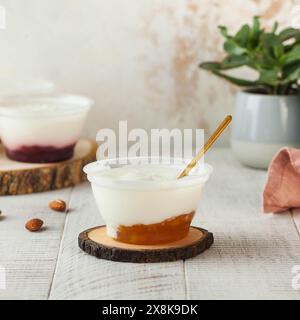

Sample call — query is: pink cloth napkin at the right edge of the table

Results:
[263,148,300,212]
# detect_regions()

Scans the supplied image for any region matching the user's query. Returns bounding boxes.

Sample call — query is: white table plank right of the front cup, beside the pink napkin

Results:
[185,150,300,299]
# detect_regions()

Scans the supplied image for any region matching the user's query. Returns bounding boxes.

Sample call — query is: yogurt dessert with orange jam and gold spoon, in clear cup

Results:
[84,160,212,245]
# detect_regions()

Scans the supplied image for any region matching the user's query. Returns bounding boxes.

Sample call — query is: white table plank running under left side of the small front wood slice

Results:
[50,185,186,299]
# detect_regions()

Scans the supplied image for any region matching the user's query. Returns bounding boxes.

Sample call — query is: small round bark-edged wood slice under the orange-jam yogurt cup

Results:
[78,226,214,263]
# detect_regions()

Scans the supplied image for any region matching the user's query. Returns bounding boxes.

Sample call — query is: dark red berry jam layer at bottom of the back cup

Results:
[5,143,75,163]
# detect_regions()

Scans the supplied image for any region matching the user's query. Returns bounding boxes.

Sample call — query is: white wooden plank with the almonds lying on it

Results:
[0,189,71,300]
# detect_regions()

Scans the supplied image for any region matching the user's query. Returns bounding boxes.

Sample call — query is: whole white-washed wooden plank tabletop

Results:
[0,149,300,299]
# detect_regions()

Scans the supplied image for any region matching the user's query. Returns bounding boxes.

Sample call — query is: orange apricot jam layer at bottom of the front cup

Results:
[115,212,195,245]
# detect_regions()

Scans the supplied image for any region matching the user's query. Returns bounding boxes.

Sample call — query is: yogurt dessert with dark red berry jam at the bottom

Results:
[0,95,92,163]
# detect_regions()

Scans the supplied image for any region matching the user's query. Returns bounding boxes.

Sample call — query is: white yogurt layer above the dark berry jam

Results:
[0,96,89,150]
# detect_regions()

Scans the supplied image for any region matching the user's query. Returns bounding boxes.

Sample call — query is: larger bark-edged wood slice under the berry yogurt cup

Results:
[0,139,97,195]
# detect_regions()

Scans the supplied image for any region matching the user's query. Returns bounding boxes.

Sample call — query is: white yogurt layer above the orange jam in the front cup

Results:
[85,164,211,237]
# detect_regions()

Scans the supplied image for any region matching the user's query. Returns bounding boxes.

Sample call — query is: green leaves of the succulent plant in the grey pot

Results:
[199,16,300,95]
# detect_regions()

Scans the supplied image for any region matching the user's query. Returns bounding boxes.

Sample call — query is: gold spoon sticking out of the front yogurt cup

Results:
[177,115,232,179]
